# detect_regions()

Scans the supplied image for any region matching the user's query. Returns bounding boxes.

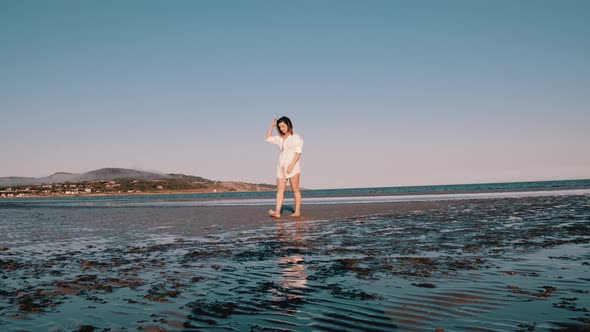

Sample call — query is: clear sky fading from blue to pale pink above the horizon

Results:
[0,0,590,188]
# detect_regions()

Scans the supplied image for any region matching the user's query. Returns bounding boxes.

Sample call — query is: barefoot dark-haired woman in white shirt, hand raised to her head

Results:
[265,116,303,218]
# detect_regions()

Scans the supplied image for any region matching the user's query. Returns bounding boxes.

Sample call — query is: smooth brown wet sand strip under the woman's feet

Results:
[2,196,584,238]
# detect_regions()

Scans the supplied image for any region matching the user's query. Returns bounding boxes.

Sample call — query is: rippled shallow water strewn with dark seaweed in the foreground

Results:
[0,195,590,331]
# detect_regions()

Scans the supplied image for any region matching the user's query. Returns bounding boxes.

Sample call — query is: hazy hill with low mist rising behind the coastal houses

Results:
[0,168,168,188]
